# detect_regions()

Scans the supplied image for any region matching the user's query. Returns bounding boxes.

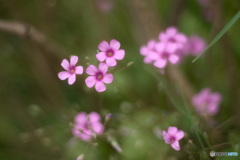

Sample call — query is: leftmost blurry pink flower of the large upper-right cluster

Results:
[140,40,156,64]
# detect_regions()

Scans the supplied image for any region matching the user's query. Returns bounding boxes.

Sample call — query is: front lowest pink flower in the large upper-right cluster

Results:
[151,42,179,69]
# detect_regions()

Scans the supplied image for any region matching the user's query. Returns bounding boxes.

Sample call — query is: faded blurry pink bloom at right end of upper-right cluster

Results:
[186,35,207,56]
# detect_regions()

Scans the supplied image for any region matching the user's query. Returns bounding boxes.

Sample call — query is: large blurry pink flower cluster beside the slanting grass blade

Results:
[140,27,206,69]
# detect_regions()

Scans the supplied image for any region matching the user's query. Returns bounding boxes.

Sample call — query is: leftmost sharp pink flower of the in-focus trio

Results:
[58,56,83,85]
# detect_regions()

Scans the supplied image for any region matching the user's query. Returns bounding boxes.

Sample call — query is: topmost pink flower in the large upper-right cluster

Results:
[159,27,187,49]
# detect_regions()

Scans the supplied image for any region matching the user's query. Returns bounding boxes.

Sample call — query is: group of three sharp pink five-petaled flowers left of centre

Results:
[58,39,125,92]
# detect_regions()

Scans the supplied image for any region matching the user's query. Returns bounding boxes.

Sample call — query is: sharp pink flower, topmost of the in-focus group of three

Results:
[96,39,125,66]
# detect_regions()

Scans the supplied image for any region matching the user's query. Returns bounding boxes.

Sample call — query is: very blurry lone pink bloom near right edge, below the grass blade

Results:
[192,88,222,116]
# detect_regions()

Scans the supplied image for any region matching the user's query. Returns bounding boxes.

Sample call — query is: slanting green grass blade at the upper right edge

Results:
[192,11,240,62]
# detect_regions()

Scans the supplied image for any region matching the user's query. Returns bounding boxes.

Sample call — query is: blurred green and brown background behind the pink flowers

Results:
[0,0,240,160]
